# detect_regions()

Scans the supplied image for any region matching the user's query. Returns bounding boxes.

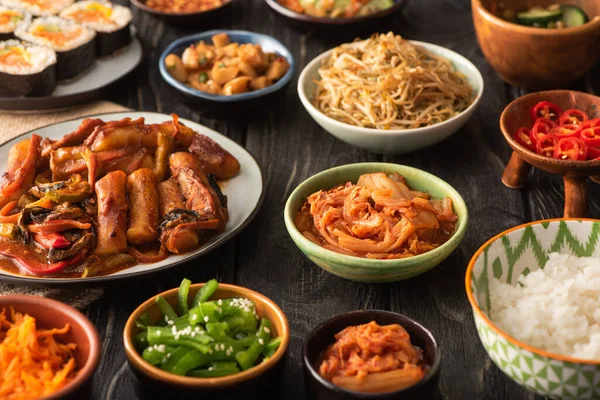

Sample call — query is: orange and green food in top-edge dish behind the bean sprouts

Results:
[278,0,394,18]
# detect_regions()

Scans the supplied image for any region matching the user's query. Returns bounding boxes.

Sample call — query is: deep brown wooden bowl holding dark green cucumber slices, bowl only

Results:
[471,0,600,90]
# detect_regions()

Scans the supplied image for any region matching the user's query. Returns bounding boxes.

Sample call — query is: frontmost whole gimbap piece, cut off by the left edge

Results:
[0,40,56,97]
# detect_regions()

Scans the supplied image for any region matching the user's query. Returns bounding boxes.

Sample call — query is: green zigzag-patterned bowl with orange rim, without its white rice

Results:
[465,218,600,400]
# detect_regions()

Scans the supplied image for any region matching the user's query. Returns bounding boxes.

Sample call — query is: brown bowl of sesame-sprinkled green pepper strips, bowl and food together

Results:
[123,279,290,398]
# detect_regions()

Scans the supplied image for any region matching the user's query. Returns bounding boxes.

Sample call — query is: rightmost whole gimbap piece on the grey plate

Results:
[60,0,133,57]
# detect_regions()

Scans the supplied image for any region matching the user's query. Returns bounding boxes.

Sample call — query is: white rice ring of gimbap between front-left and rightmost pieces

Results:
[15,17,96,52]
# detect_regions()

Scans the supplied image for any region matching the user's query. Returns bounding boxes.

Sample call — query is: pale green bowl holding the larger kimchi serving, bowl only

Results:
[284,163,469,282]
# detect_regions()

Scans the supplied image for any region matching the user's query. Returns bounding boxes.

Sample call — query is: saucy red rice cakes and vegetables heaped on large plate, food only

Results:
[0,115,240,277]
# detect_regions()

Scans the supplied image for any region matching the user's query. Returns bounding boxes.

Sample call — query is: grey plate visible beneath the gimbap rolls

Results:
[0,37,143,110]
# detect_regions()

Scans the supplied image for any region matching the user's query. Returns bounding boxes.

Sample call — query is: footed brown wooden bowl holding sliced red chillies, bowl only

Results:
[500,90,600,218]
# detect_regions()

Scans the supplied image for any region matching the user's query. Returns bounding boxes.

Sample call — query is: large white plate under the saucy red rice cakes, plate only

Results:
[0,112,263,287]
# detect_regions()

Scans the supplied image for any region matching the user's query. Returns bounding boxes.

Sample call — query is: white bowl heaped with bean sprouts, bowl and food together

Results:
[298,33,483,154]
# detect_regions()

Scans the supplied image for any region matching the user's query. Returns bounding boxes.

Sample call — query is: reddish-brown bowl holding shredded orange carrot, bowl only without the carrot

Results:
[0,295,100,400]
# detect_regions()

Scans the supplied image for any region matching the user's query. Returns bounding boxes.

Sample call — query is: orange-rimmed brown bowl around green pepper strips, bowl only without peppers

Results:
[123,283,290,398]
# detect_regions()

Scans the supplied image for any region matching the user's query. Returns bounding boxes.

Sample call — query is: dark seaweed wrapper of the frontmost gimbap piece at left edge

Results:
[0,64,56,97]
